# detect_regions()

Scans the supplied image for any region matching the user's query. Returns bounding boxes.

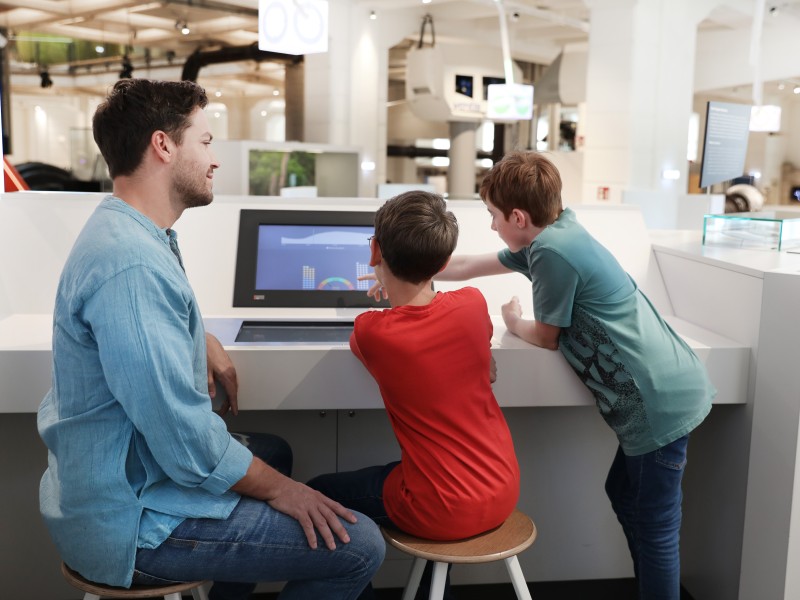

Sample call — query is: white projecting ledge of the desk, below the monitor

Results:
[0,314,750,413]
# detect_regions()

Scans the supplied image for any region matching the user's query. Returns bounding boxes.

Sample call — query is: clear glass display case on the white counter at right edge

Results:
[703,211,800,250]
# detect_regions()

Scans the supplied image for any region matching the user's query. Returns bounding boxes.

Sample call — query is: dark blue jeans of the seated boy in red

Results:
[308,461,453,600]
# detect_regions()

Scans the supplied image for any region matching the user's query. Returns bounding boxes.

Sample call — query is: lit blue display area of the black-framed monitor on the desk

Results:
[256,224,374,291]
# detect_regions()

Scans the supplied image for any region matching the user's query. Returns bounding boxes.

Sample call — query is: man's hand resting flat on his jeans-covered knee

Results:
[267,477,356,550]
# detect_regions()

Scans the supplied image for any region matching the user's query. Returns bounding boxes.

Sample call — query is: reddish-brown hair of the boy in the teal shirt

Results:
[479,151,562,227]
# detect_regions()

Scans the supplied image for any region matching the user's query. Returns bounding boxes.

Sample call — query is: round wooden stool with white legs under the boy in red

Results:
[381,510,536,600]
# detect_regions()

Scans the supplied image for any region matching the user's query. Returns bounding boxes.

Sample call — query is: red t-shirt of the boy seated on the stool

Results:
[350,287,519,540]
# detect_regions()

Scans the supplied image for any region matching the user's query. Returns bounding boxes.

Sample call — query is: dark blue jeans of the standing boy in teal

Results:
[606,435,689,600]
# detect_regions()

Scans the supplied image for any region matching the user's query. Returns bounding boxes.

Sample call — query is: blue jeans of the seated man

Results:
[133,434,386,600]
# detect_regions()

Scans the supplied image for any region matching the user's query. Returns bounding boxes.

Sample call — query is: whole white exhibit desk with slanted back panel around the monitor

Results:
[0,194,776,600]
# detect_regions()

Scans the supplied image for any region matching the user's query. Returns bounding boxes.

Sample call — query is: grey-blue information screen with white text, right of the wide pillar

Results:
[700,102,751,188]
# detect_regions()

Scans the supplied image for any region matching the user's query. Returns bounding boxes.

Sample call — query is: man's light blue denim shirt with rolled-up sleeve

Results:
[38,196,252,586]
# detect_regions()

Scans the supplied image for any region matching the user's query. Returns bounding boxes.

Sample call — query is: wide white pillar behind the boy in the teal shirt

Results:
[582,0,719,202]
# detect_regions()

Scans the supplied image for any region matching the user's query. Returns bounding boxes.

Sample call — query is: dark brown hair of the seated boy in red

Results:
[375,191,458,283]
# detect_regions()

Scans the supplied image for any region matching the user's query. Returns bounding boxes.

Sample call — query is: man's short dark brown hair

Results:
[92,79,208,179]
